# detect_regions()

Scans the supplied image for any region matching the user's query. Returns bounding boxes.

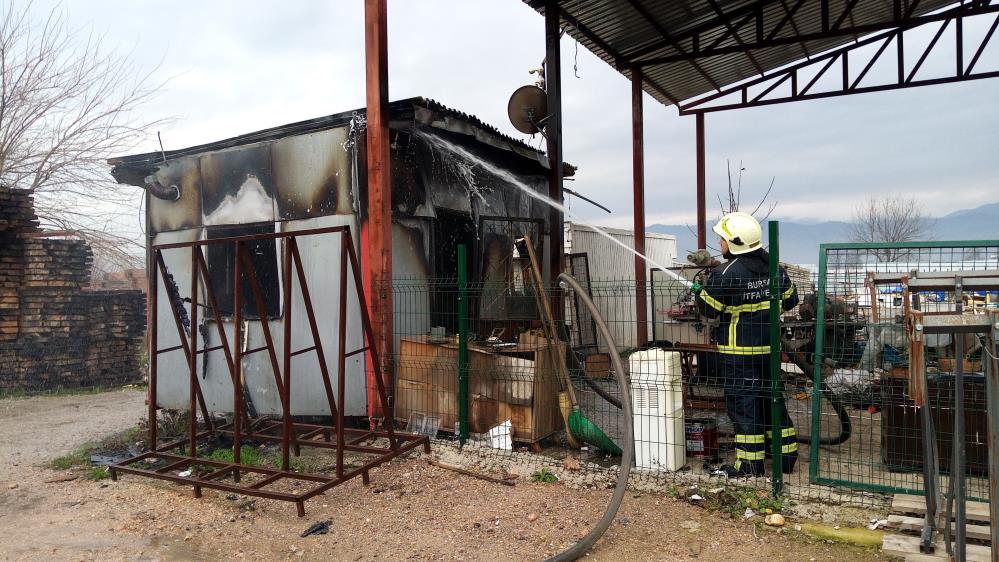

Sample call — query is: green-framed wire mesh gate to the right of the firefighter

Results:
[806,240,999,499]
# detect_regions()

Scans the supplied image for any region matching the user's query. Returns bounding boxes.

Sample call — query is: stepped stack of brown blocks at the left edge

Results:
[0,187,146,392]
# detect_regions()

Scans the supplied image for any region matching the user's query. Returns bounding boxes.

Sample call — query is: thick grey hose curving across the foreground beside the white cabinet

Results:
[548,273,635,562]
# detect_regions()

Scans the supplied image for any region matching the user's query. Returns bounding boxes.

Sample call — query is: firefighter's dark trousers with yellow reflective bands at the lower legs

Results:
[719,353,798,476]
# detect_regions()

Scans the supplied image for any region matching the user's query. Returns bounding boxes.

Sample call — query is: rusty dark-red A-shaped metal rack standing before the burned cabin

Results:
[110,226,430,517]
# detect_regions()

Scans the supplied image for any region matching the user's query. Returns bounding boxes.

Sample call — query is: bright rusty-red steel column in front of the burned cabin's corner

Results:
[360,0,392,417]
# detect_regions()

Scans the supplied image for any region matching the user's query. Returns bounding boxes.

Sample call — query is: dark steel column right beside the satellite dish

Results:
[545,0,565,284]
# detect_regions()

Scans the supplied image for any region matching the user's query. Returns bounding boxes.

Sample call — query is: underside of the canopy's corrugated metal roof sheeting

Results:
[523,0,958,105]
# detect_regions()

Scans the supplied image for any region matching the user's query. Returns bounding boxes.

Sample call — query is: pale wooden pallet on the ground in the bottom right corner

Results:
[881,494,992,562]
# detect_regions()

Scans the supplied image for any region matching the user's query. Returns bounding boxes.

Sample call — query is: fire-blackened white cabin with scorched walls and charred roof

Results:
[110,98,561,416]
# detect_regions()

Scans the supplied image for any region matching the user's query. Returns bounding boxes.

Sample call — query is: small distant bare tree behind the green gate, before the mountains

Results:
[850,193,933,262]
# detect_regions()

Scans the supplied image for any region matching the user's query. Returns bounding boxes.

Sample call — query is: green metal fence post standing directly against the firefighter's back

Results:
[769,221,784,498]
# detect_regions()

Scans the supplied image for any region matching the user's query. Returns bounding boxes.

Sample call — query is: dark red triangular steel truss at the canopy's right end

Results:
[679,0,999,115]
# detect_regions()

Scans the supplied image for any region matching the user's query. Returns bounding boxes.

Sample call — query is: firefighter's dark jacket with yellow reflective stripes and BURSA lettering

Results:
[697,249,798,355]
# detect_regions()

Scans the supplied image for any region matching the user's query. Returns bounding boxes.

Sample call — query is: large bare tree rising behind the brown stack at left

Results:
[0,2,160,274]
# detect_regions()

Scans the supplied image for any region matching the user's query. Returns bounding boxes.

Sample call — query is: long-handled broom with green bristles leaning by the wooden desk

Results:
[524,234,621,455]
